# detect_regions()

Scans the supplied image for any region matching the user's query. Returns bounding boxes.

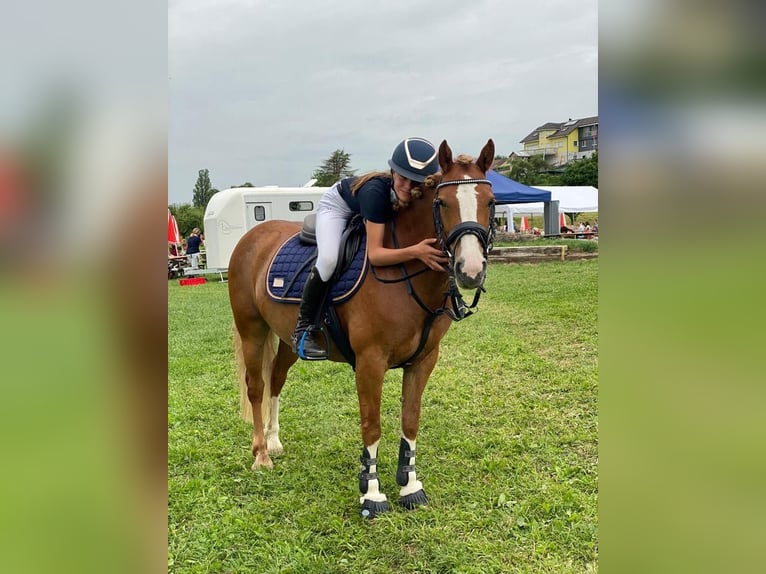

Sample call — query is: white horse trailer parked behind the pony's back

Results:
[204,186,329,269]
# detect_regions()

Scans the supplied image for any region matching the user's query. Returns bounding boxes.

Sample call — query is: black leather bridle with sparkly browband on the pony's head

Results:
[433,179,495,321]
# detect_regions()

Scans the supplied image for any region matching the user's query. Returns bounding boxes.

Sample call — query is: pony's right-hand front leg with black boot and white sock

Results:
[396,347,439,510]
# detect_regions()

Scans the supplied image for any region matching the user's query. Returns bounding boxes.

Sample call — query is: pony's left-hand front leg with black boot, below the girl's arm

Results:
[356,360,390,518]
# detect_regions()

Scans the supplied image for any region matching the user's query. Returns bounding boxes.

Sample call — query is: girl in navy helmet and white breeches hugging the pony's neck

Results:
[292,138,448,360]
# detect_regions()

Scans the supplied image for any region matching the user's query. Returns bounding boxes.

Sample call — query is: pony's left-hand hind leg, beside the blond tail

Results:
[235,328,275,470]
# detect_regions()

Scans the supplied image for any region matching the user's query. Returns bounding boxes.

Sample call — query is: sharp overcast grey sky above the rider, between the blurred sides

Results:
[168,0,598,207]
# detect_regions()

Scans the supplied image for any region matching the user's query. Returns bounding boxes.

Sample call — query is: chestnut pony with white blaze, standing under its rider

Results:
[229,140,495,518]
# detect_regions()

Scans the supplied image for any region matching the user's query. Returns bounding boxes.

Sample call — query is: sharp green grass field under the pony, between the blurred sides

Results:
[168,260,598,574]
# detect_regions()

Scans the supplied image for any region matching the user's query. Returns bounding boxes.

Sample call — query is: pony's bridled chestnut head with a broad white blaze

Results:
[434,139,495,289]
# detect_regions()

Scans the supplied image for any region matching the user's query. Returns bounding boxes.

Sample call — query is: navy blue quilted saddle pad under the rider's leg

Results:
[266,233,367,304]
